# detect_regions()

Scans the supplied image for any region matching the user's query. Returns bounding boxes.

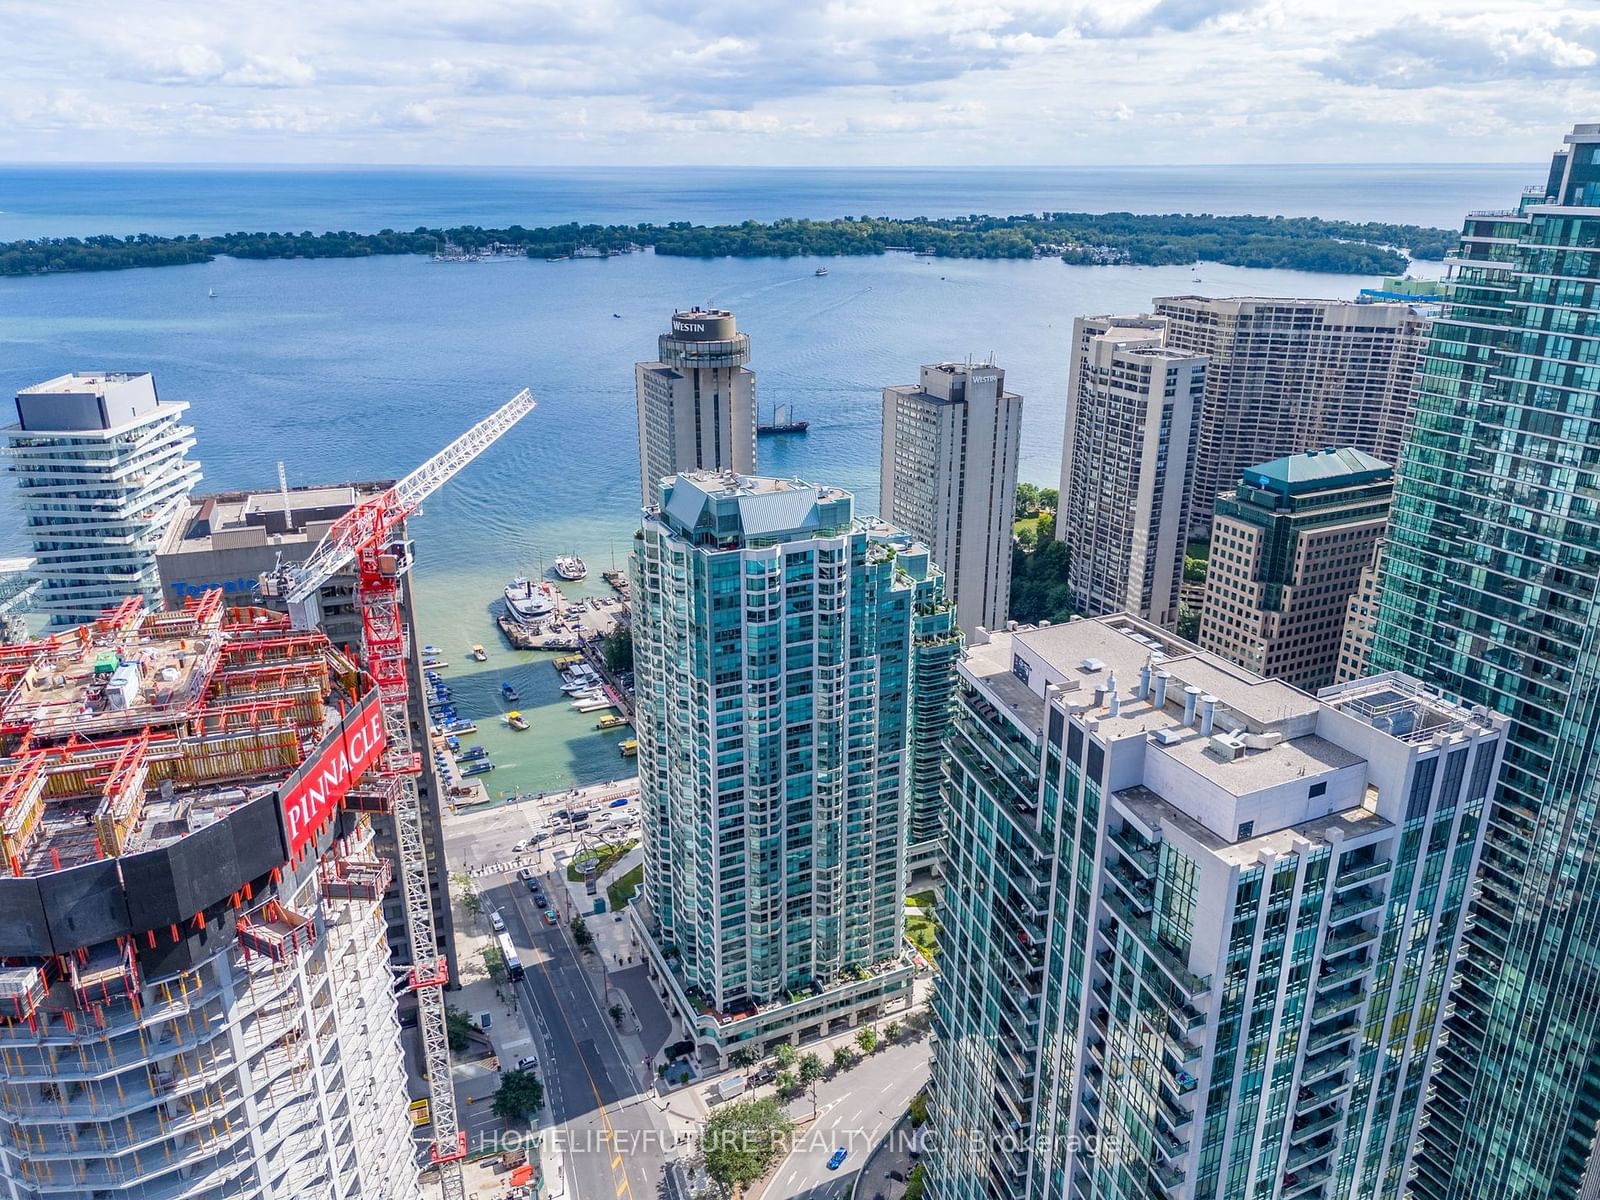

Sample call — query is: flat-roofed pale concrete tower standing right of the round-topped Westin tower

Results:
[880,363,1022,635]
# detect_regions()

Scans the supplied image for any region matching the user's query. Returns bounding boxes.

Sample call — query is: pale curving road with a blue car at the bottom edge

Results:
[763,1037,930,1200]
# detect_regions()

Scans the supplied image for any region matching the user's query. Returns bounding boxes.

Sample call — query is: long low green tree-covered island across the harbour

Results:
[0,213,1456,275]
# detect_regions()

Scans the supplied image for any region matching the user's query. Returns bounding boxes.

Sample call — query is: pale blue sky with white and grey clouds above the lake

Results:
[0,0,1600,166]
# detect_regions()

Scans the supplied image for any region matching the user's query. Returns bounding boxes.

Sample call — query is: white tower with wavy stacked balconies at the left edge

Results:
[5,371,200,624]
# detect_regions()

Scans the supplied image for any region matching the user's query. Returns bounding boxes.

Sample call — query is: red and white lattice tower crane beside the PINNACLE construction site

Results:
[262,389,534,1200]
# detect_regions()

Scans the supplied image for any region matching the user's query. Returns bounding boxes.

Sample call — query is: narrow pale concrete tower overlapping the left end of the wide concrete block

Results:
[1056,317,1206,626]
